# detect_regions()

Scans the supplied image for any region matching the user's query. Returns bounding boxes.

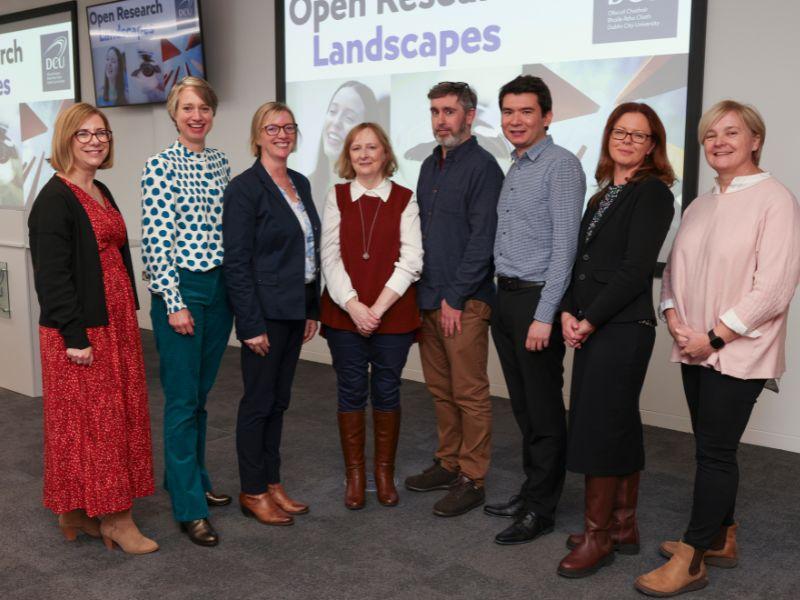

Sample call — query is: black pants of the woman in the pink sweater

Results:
[681,365,766,550]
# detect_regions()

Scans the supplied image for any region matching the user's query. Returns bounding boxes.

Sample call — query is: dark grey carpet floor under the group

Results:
[0,332,800,600]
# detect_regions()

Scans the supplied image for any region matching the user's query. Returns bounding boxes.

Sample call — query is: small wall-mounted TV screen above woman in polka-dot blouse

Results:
[86,0,206,107]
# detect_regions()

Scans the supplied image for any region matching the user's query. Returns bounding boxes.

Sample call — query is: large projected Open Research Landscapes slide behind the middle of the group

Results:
[283,0,695,260]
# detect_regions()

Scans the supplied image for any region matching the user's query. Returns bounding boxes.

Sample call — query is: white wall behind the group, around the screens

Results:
[0,0,800,452]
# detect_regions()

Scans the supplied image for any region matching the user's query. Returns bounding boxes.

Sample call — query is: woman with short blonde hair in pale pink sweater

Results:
[636,100,800,596]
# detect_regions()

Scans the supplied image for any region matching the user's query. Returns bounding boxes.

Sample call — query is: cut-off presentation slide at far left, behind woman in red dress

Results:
[0,5,79,209]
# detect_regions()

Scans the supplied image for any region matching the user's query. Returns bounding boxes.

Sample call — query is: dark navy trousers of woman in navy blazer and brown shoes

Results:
[236,319,306,494]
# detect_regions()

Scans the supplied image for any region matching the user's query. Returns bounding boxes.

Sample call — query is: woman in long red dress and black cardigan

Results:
[28,103,158,554]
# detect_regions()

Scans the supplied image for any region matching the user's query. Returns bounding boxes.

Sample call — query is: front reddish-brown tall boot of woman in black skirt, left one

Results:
[558,475,619,577]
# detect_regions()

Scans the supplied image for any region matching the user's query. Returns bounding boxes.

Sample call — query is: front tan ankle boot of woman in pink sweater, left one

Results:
[633,542,708,598]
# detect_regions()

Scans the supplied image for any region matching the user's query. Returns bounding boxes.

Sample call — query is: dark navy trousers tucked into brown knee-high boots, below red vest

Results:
[325,327,414,412]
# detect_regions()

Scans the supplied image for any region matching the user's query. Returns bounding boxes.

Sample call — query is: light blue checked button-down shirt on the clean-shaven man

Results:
[494,136,586,323]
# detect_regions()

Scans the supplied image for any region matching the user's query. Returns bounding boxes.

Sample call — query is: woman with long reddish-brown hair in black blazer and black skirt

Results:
[558,102,675,577]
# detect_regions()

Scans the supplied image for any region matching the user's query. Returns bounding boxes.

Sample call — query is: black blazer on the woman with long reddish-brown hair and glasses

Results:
[561,178,675,327]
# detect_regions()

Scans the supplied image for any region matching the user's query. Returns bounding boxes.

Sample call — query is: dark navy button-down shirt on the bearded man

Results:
[417,136,503,310]
